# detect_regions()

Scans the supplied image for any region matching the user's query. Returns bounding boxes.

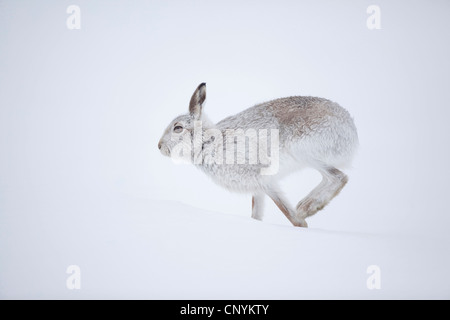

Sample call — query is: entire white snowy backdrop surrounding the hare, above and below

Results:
[0,0,450,299]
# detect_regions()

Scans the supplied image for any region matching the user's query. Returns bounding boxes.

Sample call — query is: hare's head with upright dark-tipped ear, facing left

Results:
[158,83,206,157]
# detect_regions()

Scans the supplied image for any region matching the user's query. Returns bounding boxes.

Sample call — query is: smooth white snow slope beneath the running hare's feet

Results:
[0,189,450,299]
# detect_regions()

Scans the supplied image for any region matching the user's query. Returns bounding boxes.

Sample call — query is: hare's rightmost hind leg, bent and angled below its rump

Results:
[296,166,348,219]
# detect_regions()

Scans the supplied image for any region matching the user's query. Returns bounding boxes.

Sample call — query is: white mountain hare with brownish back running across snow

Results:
[158,83,358,227]
